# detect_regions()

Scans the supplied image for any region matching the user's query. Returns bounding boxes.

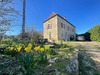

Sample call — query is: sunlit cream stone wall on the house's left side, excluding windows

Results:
[43,16,58,41]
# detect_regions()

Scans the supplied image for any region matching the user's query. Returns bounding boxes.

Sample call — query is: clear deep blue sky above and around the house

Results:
[7,0,100,35]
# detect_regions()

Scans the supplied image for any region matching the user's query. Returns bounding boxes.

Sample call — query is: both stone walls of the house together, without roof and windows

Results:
[43,15,76,42]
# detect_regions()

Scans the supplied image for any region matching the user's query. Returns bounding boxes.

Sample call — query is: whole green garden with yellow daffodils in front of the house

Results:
[0,39,77,75]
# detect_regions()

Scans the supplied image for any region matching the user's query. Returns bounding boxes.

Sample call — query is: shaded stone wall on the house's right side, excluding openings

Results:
[57,16,76,41]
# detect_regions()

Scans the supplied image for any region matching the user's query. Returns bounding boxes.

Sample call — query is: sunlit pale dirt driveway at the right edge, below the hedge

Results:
[78,42,100,71]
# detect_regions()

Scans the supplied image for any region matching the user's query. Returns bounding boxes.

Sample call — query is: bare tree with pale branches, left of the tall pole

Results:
[0,0,20,34]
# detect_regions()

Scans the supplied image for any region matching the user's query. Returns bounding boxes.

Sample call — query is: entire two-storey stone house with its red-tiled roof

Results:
[43,12,76,42]
